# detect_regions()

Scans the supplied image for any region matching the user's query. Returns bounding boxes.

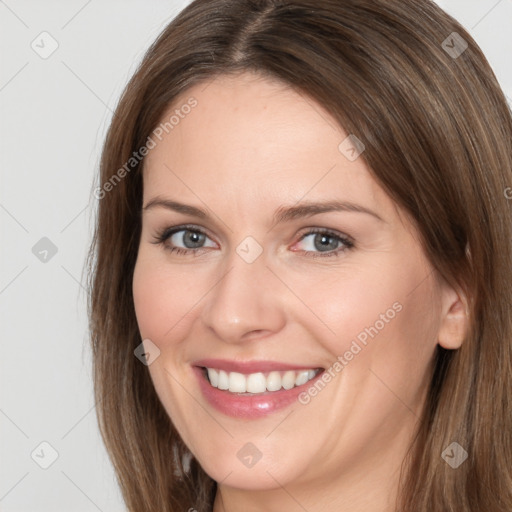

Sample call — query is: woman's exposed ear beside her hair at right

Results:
[438,283,469,350]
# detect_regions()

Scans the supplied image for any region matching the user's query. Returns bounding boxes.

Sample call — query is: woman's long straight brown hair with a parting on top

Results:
[88,0,512,512]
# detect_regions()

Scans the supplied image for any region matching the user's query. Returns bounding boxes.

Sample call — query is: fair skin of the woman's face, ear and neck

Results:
[133,73,467,512]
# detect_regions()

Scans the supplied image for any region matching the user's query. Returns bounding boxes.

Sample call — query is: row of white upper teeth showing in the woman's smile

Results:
[207,368,319,393]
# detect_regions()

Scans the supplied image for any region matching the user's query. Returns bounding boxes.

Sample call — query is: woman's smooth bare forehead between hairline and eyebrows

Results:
[144,74,392,222]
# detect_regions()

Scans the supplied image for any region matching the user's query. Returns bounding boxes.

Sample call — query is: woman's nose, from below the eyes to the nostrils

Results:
[201,251,286,343]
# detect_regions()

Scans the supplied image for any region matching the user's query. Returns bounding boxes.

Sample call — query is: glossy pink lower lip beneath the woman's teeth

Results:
[193,366,323,419]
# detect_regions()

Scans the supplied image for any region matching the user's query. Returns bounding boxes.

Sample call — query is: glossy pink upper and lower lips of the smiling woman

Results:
[193,359,322,419]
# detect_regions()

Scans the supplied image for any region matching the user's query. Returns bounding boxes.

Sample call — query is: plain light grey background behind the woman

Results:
[0,0,512,512]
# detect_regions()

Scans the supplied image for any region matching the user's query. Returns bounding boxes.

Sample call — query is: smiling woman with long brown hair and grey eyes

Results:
[90,0,512,512]
